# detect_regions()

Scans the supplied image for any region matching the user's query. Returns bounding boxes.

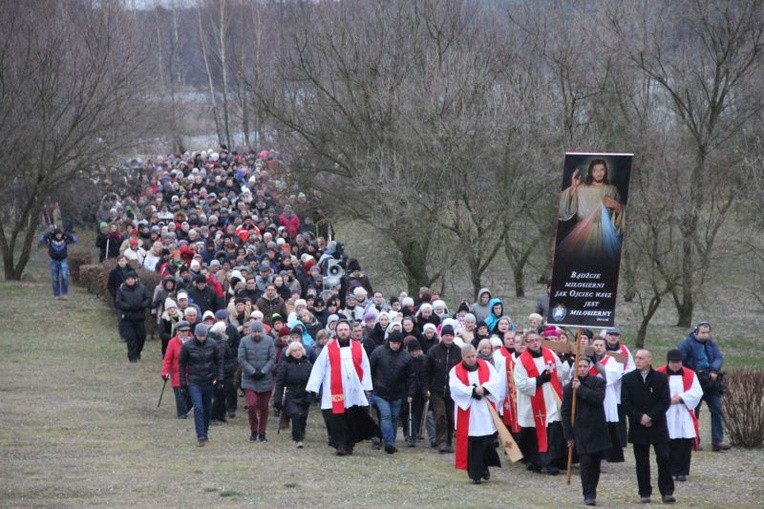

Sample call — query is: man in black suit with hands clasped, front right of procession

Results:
[621,349,676,504]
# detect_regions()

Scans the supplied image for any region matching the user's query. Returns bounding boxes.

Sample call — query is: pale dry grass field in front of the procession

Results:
[0,260,764,508]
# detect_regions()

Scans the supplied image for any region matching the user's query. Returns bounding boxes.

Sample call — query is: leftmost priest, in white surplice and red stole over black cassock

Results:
[305,320,379,456]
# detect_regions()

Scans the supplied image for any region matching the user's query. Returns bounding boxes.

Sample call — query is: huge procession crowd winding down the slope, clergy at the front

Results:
[43,147,729,505]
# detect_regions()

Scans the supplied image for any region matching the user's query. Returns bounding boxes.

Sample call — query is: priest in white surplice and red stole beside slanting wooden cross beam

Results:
[448,343,503,484]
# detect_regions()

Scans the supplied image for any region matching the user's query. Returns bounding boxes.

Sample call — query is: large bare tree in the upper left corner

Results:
[0,1,145,279]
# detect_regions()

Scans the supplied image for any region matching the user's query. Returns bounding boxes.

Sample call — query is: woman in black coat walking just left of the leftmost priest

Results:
[273,341,313,449]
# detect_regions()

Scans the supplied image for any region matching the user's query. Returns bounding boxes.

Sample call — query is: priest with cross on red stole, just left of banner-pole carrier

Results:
[515,331,570,475]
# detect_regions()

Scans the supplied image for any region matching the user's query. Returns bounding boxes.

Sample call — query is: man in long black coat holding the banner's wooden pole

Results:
[560,357,610,505]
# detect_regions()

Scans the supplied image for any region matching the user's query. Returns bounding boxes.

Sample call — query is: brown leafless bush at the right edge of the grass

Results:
[722,368,764,447]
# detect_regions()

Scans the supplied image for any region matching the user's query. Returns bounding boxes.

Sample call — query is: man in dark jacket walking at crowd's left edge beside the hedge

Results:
[114,270,151,362]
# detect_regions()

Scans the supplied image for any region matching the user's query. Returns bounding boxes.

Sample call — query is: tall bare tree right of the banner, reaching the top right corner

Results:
[611,0,764,327]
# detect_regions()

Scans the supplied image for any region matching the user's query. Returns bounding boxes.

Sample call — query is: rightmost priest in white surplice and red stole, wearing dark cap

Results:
[656,350,703,481]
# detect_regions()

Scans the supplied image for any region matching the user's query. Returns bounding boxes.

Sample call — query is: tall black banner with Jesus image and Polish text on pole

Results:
[547,152,634,327]
